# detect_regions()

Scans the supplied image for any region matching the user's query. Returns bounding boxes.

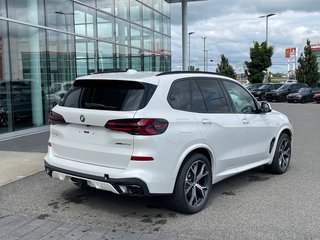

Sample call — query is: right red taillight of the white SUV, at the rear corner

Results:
[105,118,169,135]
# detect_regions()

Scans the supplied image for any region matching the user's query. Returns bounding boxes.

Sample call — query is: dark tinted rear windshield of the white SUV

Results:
[59,80,156,111]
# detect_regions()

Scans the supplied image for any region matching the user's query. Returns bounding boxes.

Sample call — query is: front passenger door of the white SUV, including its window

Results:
[223,81,277,166]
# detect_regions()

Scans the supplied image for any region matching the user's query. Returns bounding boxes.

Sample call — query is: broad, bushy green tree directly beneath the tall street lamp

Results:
[245,42,273,83]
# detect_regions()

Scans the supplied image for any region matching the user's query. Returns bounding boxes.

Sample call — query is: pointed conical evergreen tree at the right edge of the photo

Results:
[296,39,320,87]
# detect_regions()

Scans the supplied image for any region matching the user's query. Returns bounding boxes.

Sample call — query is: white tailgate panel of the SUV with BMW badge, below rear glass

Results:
[49,106,135,169]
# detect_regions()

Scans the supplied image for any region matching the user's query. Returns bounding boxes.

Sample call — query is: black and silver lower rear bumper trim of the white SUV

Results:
[44,161,151,196]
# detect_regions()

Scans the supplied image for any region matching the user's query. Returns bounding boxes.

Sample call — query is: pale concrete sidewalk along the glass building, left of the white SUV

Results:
[0,132,49,186]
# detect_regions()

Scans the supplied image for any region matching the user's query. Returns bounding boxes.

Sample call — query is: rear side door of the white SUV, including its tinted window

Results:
[191,77,243,176]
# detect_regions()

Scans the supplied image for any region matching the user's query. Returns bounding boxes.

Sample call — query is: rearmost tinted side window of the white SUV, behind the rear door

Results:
[168,80,191,111]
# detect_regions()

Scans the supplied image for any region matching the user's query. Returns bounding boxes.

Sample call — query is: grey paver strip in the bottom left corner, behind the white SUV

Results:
[0,214,178,240]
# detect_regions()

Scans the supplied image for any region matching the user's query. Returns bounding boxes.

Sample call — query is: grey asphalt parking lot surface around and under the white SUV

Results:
[0,103,320,239]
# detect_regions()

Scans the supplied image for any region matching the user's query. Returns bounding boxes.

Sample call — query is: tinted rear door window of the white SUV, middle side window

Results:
[197,78,229,113]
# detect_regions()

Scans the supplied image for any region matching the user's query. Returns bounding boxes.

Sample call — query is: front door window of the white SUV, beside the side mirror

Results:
[223,81,257,113]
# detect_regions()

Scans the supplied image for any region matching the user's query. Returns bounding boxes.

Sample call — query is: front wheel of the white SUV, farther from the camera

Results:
[265,133,291,174]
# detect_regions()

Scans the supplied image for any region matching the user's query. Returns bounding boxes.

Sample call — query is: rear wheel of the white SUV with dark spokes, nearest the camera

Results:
[166,153,212,214]
